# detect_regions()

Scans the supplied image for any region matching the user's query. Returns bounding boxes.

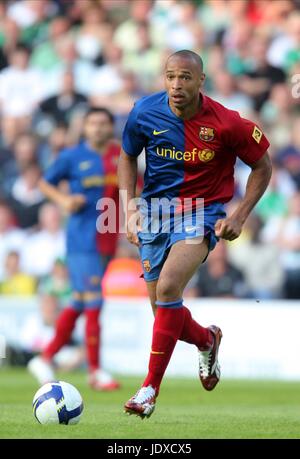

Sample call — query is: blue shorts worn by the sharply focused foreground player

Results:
[138,203,226,282]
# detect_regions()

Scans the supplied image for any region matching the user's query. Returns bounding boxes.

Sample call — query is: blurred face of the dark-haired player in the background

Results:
[84,113,113,145]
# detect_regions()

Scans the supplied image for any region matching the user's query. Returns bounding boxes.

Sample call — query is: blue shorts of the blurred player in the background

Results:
[67,252,103,293]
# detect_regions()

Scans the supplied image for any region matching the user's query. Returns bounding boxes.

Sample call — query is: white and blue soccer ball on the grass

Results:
[33,381,83,424]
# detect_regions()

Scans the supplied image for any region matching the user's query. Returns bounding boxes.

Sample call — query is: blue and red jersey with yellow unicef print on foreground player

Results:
[122,91,269,205]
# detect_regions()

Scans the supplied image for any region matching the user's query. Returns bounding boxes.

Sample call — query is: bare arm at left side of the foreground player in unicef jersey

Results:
[118,149,139,246]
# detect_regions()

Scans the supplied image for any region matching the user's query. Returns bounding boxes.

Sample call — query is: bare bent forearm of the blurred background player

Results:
[39,179,86,213]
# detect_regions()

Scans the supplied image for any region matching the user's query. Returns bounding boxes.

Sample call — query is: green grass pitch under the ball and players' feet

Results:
[0,367,300,439]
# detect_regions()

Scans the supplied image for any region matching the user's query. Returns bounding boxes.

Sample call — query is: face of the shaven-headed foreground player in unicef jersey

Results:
[165,57,205,110]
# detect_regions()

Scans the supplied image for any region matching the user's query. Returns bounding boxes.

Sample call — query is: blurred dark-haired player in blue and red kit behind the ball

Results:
[28,108,120,391]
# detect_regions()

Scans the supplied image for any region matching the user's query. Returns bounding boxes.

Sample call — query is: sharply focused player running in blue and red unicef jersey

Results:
[118,50,271,418]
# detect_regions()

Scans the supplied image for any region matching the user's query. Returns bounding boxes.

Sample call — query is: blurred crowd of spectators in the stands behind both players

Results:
[0,0,300,315]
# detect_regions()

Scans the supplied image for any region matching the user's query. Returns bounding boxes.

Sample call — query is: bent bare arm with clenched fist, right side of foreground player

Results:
[215,153,272,241]
